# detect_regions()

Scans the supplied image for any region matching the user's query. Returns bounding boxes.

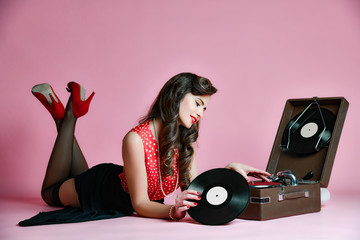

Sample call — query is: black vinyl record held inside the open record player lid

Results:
[280,107,336,154]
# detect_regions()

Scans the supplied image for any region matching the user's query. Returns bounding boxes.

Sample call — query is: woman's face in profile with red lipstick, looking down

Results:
[179,93,210,128]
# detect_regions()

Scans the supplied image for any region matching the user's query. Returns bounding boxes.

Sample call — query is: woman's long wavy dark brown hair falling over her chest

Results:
[140,73,217,190]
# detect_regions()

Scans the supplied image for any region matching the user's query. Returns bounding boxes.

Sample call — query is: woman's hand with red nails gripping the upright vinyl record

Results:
[173,190,201,219]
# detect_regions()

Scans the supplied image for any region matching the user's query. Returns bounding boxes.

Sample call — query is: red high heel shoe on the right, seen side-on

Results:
[68,82,95,118]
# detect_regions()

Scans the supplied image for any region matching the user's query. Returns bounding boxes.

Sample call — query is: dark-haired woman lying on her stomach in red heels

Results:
[20,73,270,226]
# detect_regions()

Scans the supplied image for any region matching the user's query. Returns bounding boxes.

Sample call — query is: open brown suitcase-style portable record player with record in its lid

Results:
[239,97,349,220]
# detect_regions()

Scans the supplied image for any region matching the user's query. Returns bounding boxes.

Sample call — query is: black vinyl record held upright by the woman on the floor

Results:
[188,168,250,225]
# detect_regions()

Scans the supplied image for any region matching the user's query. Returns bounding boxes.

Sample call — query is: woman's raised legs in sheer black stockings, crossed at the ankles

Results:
[41,96,88,206]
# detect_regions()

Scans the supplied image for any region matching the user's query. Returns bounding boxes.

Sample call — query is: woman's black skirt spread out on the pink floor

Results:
[19,163,141,226]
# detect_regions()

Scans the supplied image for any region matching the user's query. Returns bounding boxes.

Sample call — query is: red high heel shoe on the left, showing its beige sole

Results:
[31,83,65,120]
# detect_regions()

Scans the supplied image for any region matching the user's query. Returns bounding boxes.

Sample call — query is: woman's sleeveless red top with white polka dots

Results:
[119,120,179,201]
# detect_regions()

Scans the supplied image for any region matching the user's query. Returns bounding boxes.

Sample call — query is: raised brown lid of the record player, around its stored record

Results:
[266,97,349,187]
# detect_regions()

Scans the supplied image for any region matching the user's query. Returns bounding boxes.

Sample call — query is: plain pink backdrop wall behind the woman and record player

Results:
[0,0,360,197]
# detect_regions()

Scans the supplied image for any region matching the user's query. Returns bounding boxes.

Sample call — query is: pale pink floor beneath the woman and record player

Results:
[0,194,360,240]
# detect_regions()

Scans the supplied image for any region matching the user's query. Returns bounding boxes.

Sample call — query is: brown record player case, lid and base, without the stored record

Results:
[239,97,349,220]
